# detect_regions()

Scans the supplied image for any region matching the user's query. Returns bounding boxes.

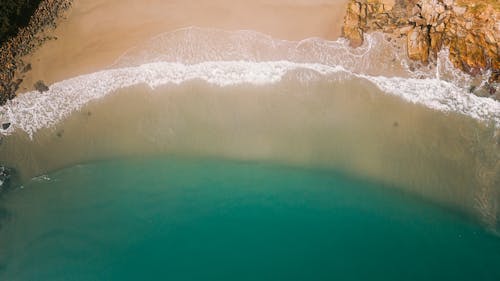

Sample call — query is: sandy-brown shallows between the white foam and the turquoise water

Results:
[0,78,500,228]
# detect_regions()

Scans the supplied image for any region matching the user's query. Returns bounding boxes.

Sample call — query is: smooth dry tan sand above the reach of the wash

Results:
[21,0,347,87]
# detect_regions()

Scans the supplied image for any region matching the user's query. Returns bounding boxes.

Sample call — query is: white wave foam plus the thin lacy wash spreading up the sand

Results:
[0,28,500,137]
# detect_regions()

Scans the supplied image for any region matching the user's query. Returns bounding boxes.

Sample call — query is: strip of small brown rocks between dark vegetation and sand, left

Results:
[0,0,72,105]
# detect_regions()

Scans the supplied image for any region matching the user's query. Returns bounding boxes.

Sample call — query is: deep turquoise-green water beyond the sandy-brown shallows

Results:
[0,158,500,280]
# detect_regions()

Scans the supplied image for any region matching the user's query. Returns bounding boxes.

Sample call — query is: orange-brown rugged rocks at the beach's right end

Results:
[343,0,500,84]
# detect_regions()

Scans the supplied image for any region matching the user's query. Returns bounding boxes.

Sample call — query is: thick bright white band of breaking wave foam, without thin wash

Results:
[0,61,500,138]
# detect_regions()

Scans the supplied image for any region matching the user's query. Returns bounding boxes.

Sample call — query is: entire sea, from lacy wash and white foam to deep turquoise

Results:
[0,27,500,280]
